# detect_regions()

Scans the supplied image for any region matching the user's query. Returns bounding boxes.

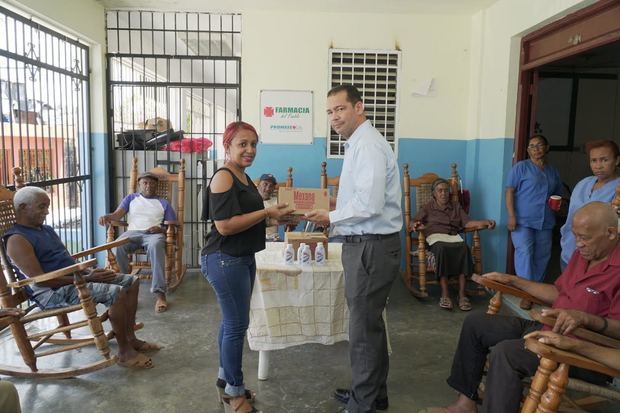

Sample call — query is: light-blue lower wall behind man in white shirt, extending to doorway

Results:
[247,138,513,271]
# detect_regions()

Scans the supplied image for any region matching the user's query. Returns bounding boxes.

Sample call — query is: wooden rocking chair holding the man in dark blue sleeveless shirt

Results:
[0,179,126,379]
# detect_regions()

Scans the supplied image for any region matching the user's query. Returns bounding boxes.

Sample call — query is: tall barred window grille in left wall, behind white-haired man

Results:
[0,7,93,252]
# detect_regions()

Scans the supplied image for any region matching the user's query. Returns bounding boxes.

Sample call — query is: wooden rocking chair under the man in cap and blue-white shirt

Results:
[107,158,187,292]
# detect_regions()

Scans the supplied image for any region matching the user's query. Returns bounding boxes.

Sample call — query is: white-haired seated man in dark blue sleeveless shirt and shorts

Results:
[4,186,160,368]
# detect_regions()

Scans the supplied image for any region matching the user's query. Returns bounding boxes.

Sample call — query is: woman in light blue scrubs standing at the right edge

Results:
[560,139,620,271]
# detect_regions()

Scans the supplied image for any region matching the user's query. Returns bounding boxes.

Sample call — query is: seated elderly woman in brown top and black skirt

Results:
[409,178,495,311]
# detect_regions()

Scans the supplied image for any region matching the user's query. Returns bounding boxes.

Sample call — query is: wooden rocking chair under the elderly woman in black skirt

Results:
[402,163,486,298]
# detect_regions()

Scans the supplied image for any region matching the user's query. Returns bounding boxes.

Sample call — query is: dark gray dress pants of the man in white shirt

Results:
[342,233,400,413]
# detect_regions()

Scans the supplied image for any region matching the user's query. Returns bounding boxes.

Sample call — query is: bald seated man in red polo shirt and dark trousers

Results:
[420,202,620,413]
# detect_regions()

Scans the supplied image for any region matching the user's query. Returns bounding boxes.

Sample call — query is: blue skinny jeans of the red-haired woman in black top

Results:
[201,251,256,397]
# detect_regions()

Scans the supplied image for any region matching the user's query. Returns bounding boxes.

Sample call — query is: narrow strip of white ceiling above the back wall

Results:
[96,0,497,15]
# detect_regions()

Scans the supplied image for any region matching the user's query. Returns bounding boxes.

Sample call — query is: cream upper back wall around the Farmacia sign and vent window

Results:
[242,12,470,139]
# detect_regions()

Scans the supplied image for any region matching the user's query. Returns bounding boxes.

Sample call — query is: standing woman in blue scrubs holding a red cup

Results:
[506,135,562,282]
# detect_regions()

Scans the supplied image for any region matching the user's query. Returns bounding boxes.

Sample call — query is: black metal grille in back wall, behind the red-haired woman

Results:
[106,10,241,267]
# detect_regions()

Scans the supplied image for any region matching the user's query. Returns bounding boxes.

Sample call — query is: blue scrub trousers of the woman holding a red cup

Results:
[510,225,552,282]
